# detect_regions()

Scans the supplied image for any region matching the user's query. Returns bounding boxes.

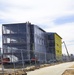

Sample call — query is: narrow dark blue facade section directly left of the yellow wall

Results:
[47,33,56,60]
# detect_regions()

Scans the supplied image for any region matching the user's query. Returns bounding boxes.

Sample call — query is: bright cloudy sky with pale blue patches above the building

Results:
[0,0,74,54]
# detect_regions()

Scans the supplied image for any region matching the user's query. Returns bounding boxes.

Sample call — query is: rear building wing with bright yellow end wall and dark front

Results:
[47,33,62,61]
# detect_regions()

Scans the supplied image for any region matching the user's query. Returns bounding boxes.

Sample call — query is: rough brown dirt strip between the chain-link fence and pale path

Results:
[0,63,60,75]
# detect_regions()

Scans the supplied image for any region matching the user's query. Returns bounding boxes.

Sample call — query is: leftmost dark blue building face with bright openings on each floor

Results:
[2,23,30,59]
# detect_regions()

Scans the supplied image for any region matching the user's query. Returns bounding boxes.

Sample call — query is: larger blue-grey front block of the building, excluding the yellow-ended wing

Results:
[2,23,47,61]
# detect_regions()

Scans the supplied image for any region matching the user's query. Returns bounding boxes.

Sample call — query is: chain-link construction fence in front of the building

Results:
[1,49,70,75]
